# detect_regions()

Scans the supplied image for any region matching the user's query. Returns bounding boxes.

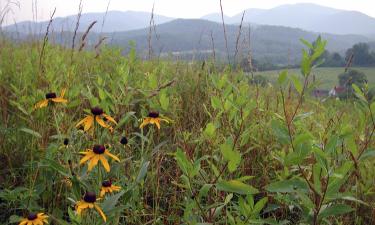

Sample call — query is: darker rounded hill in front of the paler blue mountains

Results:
[108,19,370,64]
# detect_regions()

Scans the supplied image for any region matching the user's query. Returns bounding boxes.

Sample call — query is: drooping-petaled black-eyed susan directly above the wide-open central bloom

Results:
[76,107,117,131]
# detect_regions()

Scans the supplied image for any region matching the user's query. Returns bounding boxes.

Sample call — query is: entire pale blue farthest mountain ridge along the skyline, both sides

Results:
[3,3,375,36]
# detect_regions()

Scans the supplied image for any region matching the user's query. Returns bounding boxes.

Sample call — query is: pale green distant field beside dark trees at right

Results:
[255,67,375,89]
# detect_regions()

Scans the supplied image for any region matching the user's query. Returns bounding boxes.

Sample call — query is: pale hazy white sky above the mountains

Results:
[0,0,375,23]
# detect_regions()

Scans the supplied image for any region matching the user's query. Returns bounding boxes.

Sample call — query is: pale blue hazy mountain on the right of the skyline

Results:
[203,3,375,35]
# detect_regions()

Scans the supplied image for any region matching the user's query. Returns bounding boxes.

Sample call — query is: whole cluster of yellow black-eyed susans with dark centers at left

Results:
[19,89,169,225]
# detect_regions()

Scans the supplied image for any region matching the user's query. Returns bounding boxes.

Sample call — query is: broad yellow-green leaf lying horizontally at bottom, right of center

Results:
[216,180,258,195]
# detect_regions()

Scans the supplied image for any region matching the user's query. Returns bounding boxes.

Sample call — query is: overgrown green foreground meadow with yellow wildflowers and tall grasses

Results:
[0,39,375,225]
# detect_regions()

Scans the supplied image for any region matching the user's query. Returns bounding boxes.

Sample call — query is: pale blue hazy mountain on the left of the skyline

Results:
[5,11,173,33]
